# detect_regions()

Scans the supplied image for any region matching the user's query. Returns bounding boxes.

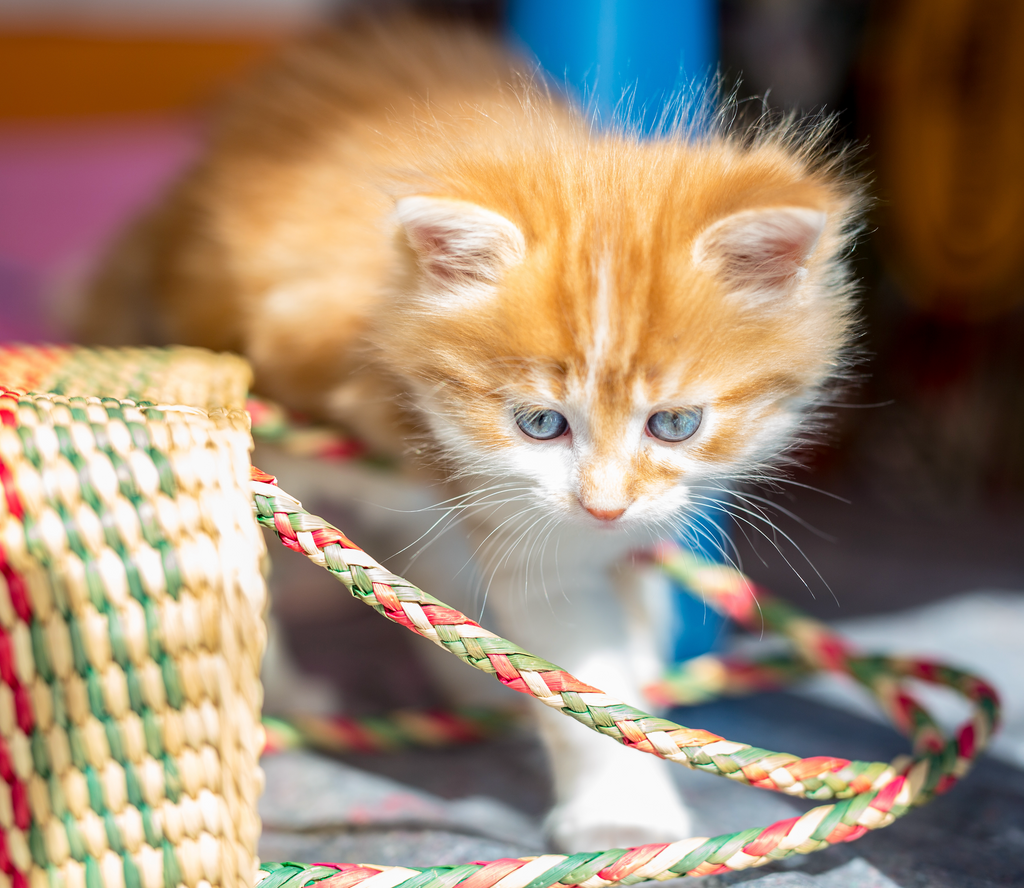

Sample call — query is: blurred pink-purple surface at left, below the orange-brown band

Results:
[0,118,200,341]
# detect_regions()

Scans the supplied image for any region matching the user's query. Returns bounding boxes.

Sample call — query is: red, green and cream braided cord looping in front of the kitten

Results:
[252,468,998,888]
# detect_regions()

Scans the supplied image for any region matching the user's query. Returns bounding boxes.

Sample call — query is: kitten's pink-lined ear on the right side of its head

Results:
[693,207,827,302]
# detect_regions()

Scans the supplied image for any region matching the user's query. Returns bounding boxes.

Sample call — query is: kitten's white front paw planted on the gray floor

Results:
[545,792,692,854]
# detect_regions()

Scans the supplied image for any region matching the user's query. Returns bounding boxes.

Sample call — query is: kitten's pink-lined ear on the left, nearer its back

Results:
[395,196,526,288]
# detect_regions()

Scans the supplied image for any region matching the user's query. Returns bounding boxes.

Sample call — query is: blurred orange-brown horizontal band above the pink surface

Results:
[0,32,283,120]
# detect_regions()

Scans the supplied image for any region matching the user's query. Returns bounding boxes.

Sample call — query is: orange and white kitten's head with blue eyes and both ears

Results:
[372,131,856,528]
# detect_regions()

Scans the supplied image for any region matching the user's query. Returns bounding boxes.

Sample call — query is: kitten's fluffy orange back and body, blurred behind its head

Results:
[79,16,568,414]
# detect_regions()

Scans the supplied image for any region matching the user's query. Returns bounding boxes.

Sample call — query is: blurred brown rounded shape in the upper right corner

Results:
[863,0,1024,321]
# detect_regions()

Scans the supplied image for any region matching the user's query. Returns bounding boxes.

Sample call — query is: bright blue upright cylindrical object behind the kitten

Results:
[508,0,729,662]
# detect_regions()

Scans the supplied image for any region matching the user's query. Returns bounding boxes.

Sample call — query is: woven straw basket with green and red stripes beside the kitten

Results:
[0,347,266,888]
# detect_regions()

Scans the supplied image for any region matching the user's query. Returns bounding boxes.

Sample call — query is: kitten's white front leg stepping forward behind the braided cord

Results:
[475,540,691,851]
